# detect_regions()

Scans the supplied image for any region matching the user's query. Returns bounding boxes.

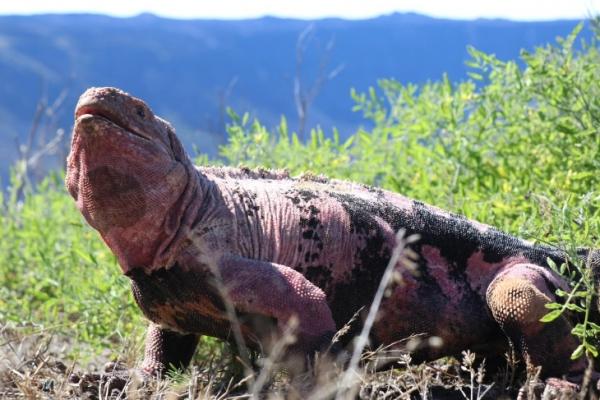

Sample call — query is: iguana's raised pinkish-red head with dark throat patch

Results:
[66,88,197,272]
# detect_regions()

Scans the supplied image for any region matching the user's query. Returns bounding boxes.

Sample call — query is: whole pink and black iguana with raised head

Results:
[66,88,596,388]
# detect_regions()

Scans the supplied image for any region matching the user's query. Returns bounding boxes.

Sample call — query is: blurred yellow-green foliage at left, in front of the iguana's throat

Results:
[0,174,145,350]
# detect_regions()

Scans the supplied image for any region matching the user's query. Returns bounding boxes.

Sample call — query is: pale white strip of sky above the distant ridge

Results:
[0,0,600,20]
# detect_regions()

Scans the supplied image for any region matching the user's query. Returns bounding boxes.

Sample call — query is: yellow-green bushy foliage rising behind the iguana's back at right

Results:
[221,27,600,244]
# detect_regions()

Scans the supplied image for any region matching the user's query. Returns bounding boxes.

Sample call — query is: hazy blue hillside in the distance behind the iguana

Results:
[0,14,577,180]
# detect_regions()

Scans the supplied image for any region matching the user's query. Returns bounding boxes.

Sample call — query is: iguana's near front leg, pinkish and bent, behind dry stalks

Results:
[217,256,336,355]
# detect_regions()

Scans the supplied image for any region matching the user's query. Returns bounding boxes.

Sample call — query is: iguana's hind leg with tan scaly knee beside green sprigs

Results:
[486,264,585,377]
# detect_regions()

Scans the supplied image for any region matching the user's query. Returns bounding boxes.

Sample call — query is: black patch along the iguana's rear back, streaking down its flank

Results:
[329,192,564,340]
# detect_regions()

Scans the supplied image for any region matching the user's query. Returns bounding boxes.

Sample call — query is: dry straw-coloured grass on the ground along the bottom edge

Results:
[0,318,597,400]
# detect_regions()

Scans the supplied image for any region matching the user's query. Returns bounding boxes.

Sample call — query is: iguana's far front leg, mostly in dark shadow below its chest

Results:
[142,323,199,376]
